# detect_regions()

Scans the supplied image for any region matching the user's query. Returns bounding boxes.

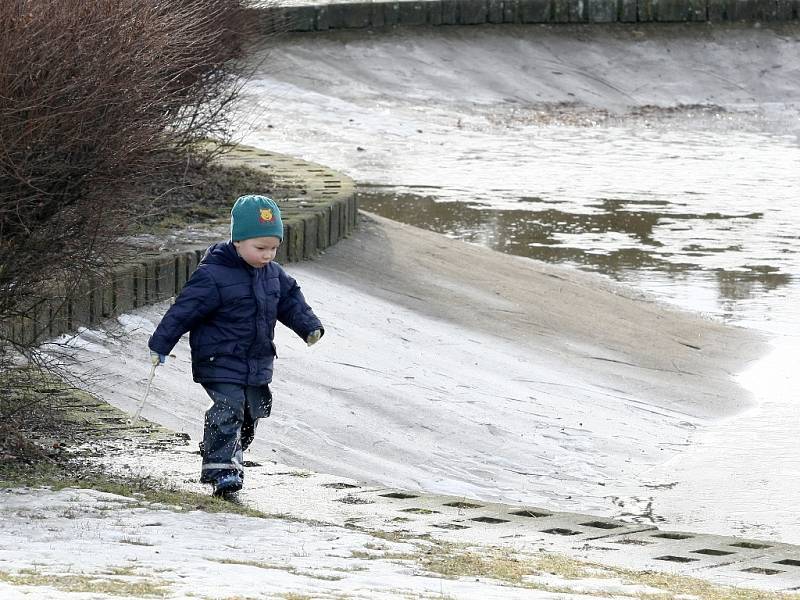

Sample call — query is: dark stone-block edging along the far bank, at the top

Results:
[253,0,800,33]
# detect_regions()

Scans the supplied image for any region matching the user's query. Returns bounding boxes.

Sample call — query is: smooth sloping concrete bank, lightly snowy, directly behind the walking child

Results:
[37,218,780,541]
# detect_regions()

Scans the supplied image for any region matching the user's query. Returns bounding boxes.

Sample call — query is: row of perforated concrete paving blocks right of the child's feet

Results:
[358,488,800,591]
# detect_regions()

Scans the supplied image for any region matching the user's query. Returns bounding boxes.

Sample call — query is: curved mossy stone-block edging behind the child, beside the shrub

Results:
[5,145,358,347]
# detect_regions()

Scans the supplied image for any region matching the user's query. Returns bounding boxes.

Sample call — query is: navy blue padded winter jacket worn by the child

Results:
[149,242,324,385]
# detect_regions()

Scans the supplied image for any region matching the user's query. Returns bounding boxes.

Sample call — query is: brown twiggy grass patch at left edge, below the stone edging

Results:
[0,369,272,518]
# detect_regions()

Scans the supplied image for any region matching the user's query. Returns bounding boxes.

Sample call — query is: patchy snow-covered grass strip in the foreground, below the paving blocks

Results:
[0,488,724,600]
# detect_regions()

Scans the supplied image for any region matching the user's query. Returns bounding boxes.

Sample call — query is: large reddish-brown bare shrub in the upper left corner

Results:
[0,0,252,364]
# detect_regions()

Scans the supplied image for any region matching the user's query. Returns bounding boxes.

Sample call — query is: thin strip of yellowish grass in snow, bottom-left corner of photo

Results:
[0,571,170,598]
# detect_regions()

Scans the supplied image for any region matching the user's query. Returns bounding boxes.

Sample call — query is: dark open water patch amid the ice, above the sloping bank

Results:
[359,186,792,310]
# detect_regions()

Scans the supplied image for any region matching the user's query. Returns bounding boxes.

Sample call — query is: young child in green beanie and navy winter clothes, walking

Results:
[148,195,325,496]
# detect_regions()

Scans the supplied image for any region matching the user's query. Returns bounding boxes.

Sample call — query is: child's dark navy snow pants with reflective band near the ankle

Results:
[200,383,272,483]
